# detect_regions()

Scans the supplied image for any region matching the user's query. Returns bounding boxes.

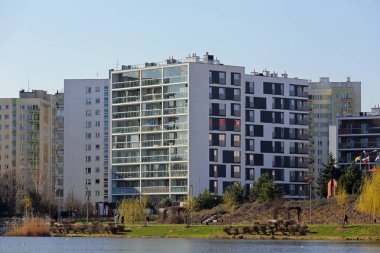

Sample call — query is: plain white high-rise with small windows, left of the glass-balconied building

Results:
[63,79,109,208]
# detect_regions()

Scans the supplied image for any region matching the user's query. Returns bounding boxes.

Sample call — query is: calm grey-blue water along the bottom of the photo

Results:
[0,237,380,253]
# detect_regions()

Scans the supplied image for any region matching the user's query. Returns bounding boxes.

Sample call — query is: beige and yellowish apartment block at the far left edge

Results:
[0,90,59,213]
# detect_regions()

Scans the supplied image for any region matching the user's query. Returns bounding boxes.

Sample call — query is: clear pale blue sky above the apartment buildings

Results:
[0,0,380,111]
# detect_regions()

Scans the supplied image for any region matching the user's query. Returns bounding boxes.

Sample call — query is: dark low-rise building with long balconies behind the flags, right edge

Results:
[330,107,380,169]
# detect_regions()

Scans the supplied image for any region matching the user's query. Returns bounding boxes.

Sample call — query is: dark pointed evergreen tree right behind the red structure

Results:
[317,153,342,198]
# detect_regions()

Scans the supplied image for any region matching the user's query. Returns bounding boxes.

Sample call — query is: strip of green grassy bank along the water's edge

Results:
[68,224,380,240]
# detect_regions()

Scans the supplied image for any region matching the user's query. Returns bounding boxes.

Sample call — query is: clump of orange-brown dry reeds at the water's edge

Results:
[5,218,50,236]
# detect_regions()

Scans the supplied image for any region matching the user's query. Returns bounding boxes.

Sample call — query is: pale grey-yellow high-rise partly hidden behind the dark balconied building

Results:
[308,77,361,188]
